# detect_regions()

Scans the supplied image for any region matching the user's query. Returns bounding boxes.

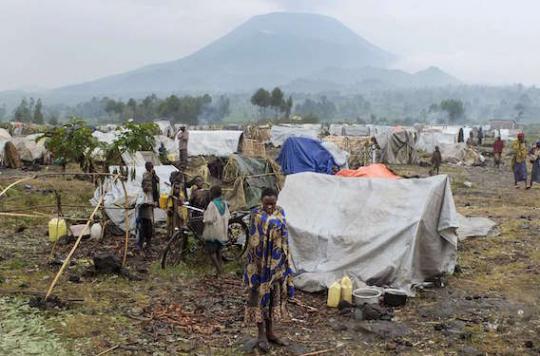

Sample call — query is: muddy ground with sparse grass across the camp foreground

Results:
[0,166,540,355]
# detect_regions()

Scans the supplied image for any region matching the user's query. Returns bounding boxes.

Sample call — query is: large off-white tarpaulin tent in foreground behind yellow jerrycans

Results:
[279,173,459,292]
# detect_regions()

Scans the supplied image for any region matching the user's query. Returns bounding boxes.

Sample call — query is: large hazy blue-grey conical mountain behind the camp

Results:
[56,13,394,95]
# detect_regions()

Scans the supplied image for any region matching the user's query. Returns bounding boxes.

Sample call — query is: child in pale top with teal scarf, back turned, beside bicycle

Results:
[203,186,231,276]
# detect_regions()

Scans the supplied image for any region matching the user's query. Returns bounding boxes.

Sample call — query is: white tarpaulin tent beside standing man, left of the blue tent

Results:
[187,130,243,157]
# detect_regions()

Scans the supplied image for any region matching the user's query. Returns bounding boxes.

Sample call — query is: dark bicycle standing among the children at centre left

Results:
[161,196,249,269]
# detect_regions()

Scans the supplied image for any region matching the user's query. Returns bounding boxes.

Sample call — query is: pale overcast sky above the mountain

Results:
[0,0,540,90]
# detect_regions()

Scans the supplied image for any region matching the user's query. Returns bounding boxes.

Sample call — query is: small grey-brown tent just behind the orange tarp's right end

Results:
[375,130,418,164]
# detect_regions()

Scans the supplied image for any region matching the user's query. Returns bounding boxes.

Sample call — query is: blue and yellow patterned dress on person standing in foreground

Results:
[244,207,294,323]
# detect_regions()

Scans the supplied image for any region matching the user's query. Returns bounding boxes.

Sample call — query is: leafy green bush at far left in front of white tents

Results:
[36,117,99,173]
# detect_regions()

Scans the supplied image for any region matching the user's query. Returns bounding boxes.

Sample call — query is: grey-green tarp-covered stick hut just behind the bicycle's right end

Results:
[223,154,283,211]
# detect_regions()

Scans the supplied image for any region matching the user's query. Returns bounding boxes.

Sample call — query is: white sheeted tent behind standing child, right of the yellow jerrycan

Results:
[90,165,177,233]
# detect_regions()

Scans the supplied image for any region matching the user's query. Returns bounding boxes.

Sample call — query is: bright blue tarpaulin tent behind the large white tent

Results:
[277,137,337,174]
